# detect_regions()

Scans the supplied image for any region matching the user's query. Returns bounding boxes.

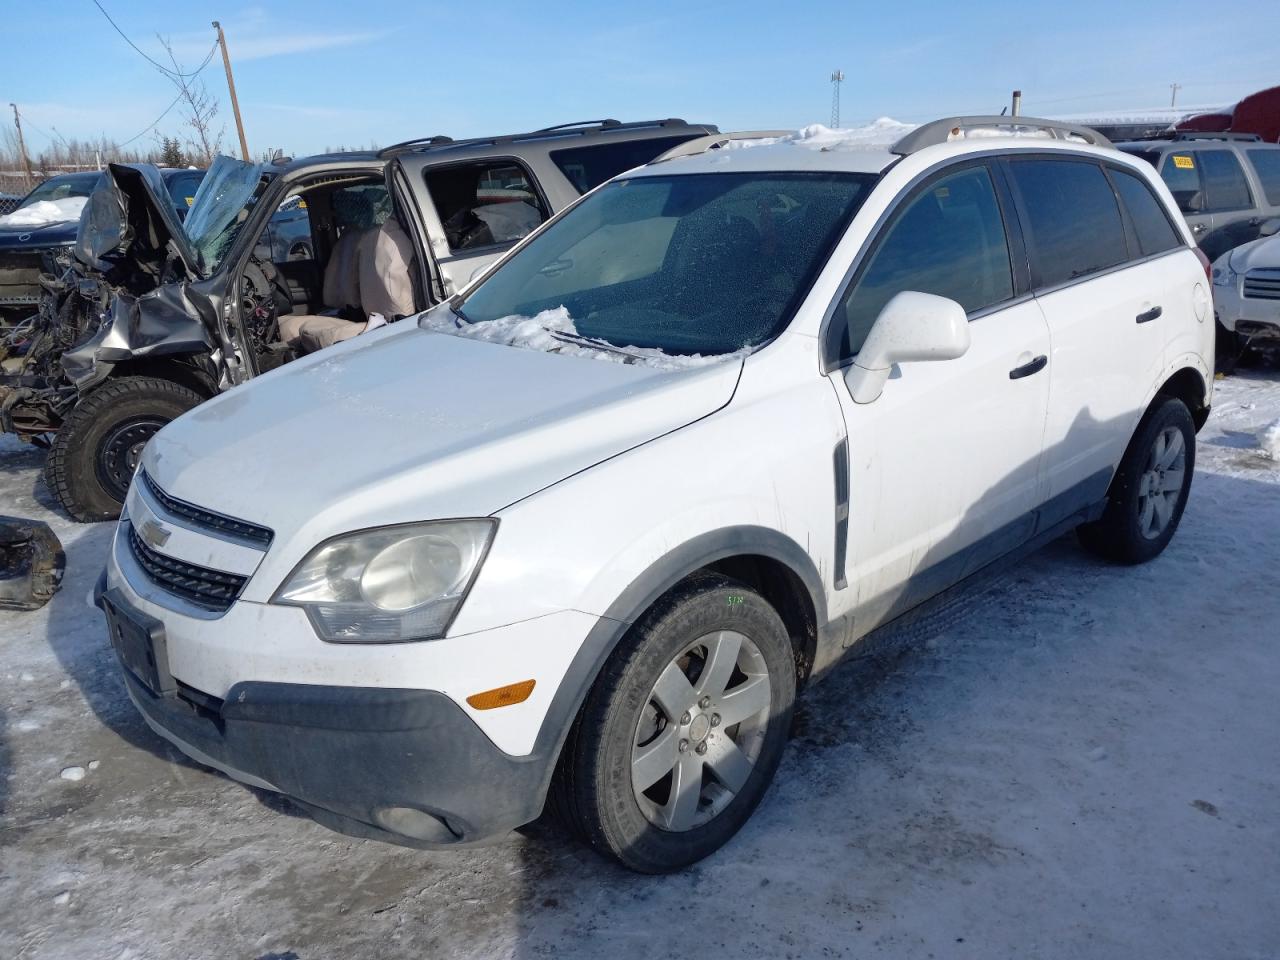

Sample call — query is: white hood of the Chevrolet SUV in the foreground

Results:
[142,323,741,552]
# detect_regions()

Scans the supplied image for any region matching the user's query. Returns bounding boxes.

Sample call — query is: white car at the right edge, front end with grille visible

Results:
[1213,219,1280,356]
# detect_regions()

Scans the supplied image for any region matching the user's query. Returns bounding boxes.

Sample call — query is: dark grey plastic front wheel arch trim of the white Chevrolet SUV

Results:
[532,526,827,804]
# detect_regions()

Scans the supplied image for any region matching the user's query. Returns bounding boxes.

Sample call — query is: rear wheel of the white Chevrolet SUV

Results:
[1076,397,1196,563]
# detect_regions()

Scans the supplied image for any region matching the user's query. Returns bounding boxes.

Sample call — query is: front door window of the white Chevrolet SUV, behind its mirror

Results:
[836,166,1014,361]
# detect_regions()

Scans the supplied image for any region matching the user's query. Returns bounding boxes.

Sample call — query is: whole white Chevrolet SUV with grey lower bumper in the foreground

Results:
[100,118,1213,872]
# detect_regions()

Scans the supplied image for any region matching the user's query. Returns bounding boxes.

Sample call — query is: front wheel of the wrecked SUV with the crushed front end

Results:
[45,376,202,524]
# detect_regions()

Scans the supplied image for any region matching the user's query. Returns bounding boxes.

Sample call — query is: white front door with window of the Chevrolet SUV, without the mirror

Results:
[831,163,1050,634]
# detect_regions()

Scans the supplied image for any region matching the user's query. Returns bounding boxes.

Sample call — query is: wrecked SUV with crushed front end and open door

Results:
[0,119,716,521]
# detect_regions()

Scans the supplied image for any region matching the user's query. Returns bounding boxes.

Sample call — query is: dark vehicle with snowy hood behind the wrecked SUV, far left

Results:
[0,168,205,311]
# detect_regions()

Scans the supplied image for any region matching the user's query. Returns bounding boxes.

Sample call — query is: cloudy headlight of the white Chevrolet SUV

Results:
[271,520,498,643]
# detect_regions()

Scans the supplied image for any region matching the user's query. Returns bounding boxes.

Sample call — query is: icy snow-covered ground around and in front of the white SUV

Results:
[0,371,1280,960]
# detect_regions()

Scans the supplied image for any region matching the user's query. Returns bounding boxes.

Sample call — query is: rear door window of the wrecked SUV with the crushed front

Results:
[422,160,548,253]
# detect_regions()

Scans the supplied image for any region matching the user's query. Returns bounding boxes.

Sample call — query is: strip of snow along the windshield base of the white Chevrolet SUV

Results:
[417,306,751,370]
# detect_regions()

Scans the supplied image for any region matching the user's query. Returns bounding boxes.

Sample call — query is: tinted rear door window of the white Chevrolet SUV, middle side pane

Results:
[1009,160,1128,287]
